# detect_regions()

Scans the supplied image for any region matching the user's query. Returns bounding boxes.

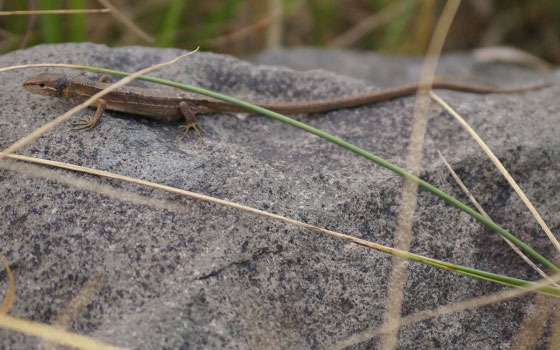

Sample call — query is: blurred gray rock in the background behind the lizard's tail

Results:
[251,47,542,87]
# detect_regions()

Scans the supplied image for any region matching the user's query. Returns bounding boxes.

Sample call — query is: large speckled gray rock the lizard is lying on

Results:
[0,44,560,349]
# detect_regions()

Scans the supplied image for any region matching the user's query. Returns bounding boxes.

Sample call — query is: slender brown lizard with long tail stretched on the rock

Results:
[23,73,550,138]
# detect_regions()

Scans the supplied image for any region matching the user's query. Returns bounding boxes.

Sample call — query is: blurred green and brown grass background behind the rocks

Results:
[0,0,560,63]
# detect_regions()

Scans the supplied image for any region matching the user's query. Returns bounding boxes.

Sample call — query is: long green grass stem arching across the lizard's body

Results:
[73,66,560,272]
